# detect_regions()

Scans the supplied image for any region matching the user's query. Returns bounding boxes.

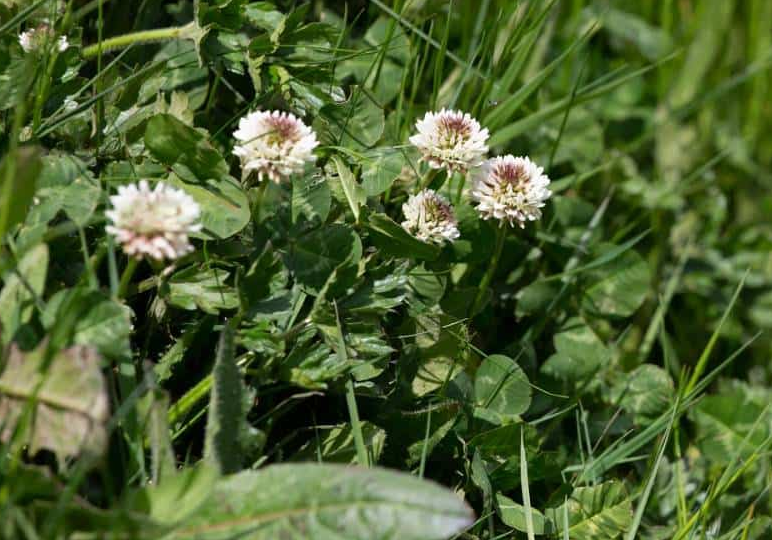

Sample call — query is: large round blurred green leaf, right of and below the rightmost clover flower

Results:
[582,244,651,317]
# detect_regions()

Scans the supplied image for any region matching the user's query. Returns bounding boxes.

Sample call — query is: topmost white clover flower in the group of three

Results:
[410,109,488,172]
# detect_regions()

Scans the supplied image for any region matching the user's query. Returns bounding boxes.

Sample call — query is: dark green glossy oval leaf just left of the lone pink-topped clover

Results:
[145,114,228,180]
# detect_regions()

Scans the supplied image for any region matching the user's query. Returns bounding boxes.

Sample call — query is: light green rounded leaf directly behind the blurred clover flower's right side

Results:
[167,174,251,239]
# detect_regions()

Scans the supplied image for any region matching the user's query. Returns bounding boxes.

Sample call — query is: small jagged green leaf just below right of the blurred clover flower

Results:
[165,266,239,315]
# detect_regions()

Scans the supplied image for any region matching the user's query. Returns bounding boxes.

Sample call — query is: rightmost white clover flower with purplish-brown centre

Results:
[472,155,552,227]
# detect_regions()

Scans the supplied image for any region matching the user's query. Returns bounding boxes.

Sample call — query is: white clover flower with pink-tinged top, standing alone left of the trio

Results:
[233,111,319,183]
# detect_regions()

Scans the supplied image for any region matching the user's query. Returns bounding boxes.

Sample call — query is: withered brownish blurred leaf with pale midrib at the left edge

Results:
[0,343,110,461]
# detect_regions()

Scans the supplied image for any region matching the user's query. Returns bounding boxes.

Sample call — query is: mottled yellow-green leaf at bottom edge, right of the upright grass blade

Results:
[544,481,633,540]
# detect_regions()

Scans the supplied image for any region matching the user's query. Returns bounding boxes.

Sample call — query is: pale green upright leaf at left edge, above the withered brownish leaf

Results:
[0,244,48,343]
